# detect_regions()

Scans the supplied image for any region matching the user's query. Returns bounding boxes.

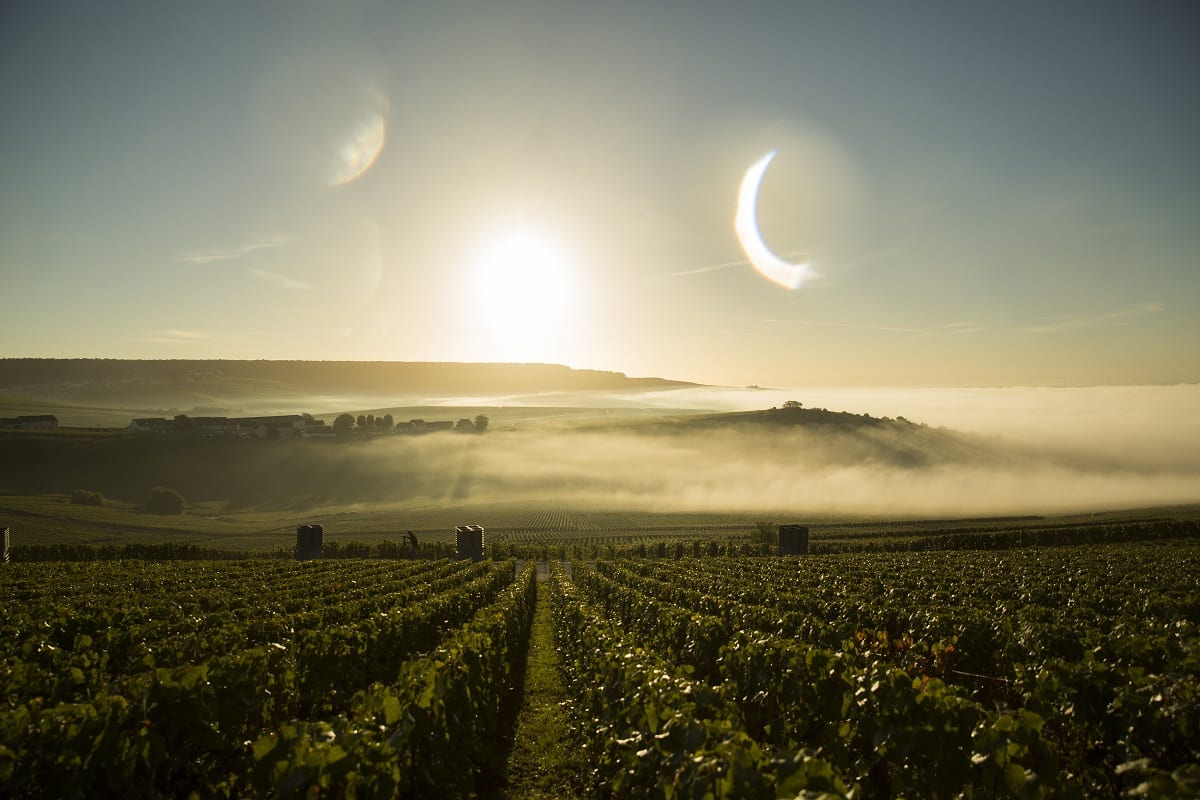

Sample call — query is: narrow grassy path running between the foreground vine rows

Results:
[504,564,583,800]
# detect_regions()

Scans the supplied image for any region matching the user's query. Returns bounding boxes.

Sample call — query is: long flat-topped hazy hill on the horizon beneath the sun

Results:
[0,359,696,409]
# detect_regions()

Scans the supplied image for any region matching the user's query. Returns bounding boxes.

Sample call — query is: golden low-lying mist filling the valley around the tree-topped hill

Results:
[278,385,1200,516]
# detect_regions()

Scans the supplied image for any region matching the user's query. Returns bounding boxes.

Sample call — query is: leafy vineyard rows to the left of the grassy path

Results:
[0,561,535,798]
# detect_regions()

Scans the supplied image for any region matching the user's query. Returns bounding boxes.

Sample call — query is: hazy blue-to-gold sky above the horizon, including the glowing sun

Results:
[0,0,1200,387]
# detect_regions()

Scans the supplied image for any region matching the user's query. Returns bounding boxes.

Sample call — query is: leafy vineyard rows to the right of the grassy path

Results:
[553,543,1200,798]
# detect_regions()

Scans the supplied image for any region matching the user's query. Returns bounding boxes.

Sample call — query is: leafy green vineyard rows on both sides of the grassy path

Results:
[0,536,1200,798]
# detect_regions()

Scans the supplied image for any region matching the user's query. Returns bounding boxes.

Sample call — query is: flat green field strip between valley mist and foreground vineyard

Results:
[0,494,1200,559]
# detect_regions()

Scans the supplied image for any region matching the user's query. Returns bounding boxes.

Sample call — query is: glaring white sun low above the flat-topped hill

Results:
[469,229,575,361]
